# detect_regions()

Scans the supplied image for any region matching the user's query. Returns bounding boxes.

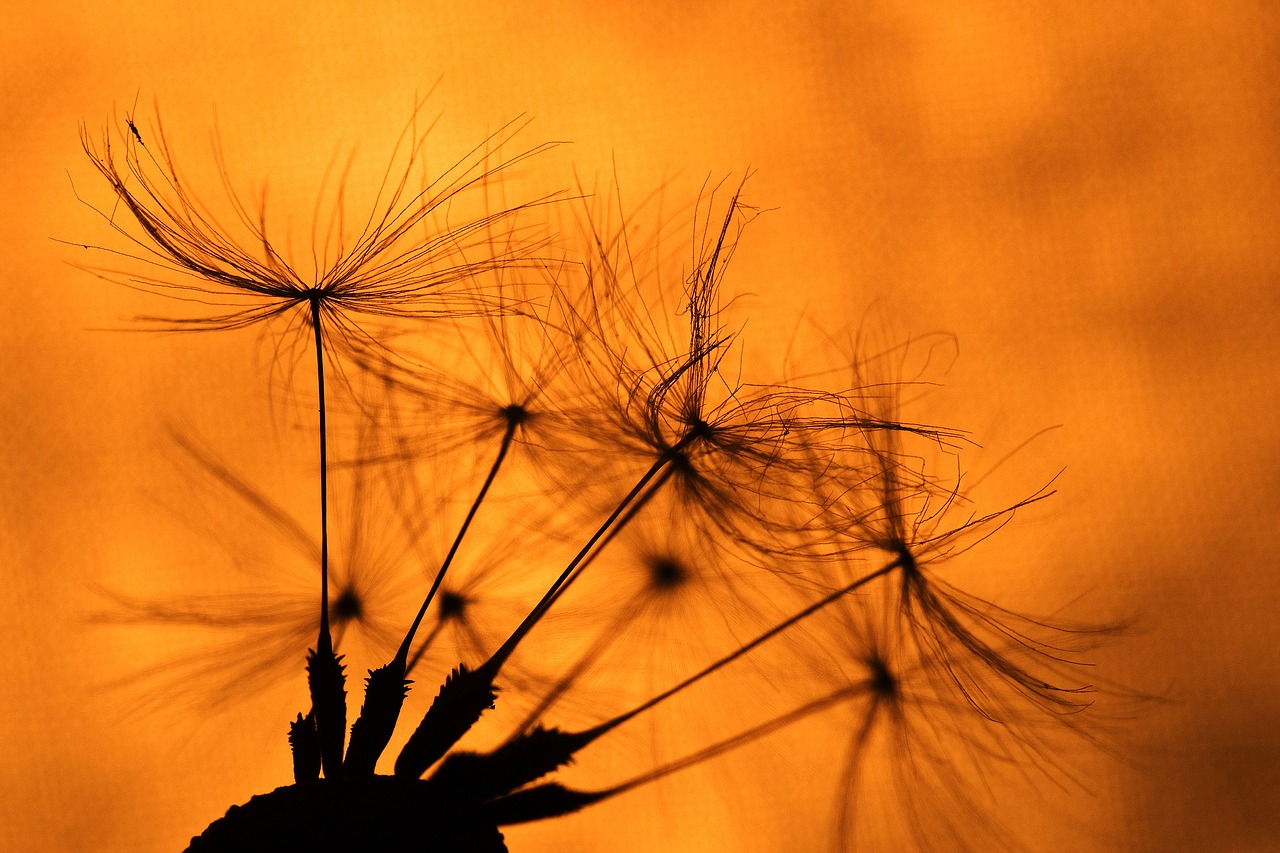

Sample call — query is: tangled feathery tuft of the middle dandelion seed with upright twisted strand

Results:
[565,178,950,552]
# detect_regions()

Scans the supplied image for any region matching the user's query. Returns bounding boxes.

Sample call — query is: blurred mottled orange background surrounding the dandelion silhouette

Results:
[0,0,1280,853]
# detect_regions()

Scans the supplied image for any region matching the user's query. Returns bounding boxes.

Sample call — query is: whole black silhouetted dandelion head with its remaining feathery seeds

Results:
[72,101,1098,852]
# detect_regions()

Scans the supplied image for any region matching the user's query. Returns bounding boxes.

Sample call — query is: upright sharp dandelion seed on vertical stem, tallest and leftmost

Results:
[81,97,563,775]
